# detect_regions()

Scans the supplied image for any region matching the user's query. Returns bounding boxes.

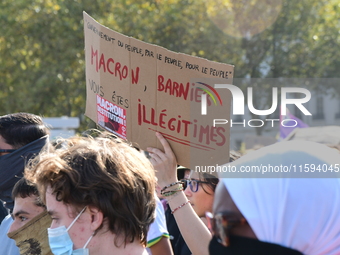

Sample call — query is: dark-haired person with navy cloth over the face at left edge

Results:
[0,112,49,255]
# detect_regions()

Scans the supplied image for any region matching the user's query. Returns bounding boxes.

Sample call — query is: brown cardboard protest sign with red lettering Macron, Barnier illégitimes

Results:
[84,12,234,169]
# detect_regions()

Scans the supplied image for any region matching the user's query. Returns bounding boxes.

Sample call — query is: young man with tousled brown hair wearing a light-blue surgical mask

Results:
[25,134,156,255]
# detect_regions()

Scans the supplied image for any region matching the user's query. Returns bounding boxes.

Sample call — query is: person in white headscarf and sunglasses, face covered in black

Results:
[207,141,340,255]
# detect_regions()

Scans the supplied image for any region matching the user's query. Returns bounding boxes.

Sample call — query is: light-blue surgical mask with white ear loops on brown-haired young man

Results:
[47,206,93,255]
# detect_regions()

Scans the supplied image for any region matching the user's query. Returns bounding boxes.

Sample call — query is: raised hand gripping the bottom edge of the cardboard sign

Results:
[147,132,178,188]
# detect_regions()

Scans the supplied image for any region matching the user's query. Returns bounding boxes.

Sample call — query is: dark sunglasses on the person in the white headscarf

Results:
[205,212,248,247]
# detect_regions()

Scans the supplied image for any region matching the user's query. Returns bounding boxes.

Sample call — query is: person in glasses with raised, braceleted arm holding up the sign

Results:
[147,132,236,255]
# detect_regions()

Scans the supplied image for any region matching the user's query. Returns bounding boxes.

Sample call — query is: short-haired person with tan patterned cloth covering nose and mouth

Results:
[7,178,52,255]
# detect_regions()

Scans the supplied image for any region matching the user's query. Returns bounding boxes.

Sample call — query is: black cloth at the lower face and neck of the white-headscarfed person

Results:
[209,235,303,255]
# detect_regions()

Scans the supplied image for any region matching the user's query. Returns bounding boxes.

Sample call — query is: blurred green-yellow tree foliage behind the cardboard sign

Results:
[0,0,340,131]
